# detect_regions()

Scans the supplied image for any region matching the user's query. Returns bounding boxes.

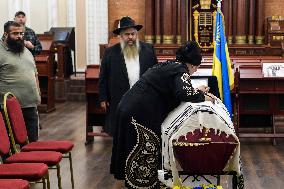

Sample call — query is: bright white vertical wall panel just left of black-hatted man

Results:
[86,0,108,65]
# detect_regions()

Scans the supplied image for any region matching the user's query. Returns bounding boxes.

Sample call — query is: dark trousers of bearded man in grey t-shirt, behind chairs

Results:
[22,107,39,142]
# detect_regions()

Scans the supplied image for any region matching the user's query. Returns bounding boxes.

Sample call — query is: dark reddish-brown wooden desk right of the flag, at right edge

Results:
[234,64,284,143]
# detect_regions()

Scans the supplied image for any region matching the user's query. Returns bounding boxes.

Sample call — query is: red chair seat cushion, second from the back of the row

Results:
[5,151,62,166]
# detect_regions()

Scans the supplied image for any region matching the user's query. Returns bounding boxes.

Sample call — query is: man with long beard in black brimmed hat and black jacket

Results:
[99,16,157,136]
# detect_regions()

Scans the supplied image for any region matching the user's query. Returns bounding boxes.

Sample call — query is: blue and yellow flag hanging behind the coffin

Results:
[212,8,234,117]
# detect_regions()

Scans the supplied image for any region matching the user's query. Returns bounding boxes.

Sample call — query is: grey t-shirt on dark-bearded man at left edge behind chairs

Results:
[0,41,40,108]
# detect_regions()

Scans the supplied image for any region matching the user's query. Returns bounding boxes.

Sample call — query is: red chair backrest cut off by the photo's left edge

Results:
[0,113,10,156]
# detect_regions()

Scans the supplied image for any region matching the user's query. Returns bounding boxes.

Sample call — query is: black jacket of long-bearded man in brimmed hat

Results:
[99,42,157,134]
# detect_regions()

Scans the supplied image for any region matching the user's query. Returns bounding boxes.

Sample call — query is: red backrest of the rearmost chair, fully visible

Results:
[6,97,27,144]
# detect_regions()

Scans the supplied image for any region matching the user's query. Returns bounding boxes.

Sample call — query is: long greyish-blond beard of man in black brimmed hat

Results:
[120,38,140,59]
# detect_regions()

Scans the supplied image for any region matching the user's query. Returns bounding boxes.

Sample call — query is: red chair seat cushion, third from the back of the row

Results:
[0,163,48,181]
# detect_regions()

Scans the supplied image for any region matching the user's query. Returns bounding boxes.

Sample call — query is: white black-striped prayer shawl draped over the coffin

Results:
[158,100,240,187]
